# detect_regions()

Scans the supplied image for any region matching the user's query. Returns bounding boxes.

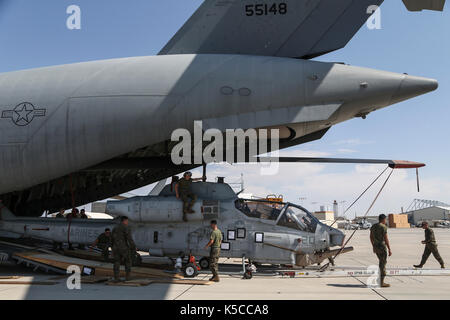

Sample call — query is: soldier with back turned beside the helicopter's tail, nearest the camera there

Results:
[111,217,136,282]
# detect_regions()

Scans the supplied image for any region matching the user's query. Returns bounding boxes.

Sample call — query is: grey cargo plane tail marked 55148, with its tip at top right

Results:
[160,0,445,58]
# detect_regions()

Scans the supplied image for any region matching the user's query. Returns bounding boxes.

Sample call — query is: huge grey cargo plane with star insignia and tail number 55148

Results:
[0,0,445,216]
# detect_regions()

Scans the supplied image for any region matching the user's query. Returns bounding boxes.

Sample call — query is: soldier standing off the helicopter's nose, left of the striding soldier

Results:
[370,214,392,288]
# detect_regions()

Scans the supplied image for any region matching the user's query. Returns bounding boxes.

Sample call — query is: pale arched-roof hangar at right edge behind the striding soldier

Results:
[406,199,450,225]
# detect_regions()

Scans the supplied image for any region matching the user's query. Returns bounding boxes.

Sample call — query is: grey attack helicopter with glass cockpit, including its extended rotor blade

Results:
[0,157,425,277]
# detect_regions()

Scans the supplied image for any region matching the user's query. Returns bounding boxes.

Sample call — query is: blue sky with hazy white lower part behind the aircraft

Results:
[0,0,450,216]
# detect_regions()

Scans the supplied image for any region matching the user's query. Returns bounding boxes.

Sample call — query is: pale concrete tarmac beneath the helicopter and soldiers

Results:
[0,229,450,300]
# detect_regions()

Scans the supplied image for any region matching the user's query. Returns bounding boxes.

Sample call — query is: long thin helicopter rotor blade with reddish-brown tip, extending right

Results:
[253,157,426,169]
